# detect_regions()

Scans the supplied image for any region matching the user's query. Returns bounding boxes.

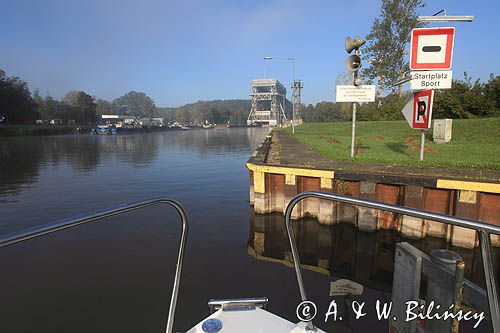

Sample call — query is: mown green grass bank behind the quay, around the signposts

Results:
[284,118,500,170]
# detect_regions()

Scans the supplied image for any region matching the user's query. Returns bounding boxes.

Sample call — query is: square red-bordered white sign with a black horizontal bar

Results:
[410,27,455,70]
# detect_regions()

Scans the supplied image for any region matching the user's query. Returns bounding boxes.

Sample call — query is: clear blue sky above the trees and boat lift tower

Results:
[0,0,500,106]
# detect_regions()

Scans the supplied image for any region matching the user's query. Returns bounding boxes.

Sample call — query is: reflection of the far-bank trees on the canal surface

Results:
[0,128,266,203]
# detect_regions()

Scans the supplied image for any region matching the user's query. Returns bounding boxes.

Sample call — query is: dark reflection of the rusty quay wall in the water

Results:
[247,213,500,292]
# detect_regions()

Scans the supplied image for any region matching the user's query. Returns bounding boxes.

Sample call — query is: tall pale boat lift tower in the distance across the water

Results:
[247,79,287,127]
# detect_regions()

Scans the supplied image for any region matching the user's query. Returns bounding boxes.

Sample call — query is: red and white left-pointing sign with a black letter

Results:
[402,90,434,129]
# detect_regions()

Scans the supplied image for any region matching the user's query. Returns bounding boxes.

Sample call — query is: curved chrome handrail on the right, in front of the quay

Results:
[285,191,500,333]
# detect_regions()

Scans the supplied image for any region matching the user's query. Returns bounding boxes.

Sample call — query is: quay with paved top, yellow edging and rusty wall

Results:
[247,130,500,248]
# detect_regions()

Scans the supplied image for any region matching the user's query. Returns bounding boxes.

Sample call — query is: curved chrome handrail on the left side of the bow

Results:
[0,198,188,333]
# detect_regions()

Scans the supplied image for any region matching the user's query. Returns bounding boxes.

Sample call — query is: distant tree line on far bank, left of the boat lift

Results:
[0,69,254,125]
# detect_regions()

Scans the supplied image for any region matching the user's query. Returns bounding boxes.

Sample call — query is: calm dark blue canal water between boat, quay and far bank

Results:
[0,128,489,333]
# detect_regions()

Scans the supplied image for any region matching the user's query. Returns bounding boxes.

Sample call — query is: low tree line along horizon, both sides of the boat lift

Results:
[0,64,500,125]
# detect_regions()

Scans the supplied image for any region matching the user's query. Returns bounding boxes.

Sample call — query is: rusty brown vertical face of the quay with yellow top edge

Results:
[247,162,500,248]
